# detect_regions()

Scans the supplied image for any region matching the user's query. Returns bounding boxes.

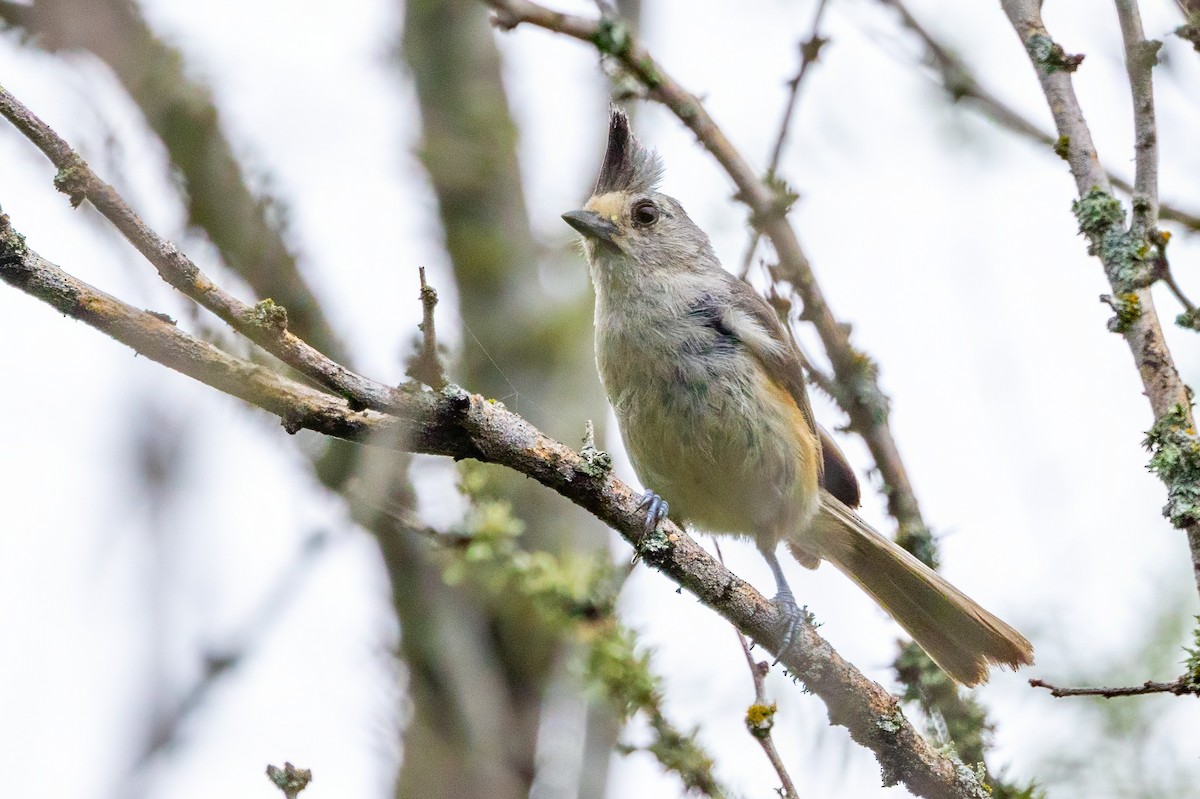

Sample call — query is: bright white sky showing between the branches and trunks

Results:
[0,0,1200,799]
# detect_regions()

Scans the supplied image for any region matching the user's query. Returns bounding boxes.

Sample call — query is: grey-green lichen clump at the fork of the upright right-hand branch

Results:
[1070,187,1154,295]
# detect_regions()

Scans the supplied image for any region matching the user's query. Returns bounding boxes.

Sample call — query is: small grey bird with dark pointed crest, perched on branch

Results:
[563,109,1033,685]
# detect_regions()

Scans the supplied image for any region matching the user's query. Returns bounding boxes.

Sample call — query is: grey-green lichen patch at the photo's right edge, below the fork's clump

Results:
[1142,403,1200,528]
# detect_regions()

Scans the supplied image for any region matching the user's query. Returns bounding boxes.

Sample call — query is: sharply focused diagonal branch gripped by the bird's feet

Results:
[0,216,986,799]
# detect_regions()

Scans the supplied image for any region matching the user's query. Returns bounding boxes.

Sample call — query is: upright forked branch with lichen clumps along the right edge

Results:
[1002,0,1200,597]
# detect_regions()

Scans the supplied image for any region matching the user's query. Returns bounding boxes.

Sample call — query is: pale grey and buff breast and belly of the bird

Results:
[596,289,817,539]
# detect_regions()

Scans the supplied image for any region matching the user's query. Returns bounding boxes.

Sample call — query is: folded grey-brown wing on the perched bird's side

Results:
[728,275,862,507]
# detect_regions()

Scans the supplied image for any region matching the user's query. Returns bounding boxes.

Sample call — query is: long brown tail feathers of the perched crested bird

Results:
[788,492,1033,685]
